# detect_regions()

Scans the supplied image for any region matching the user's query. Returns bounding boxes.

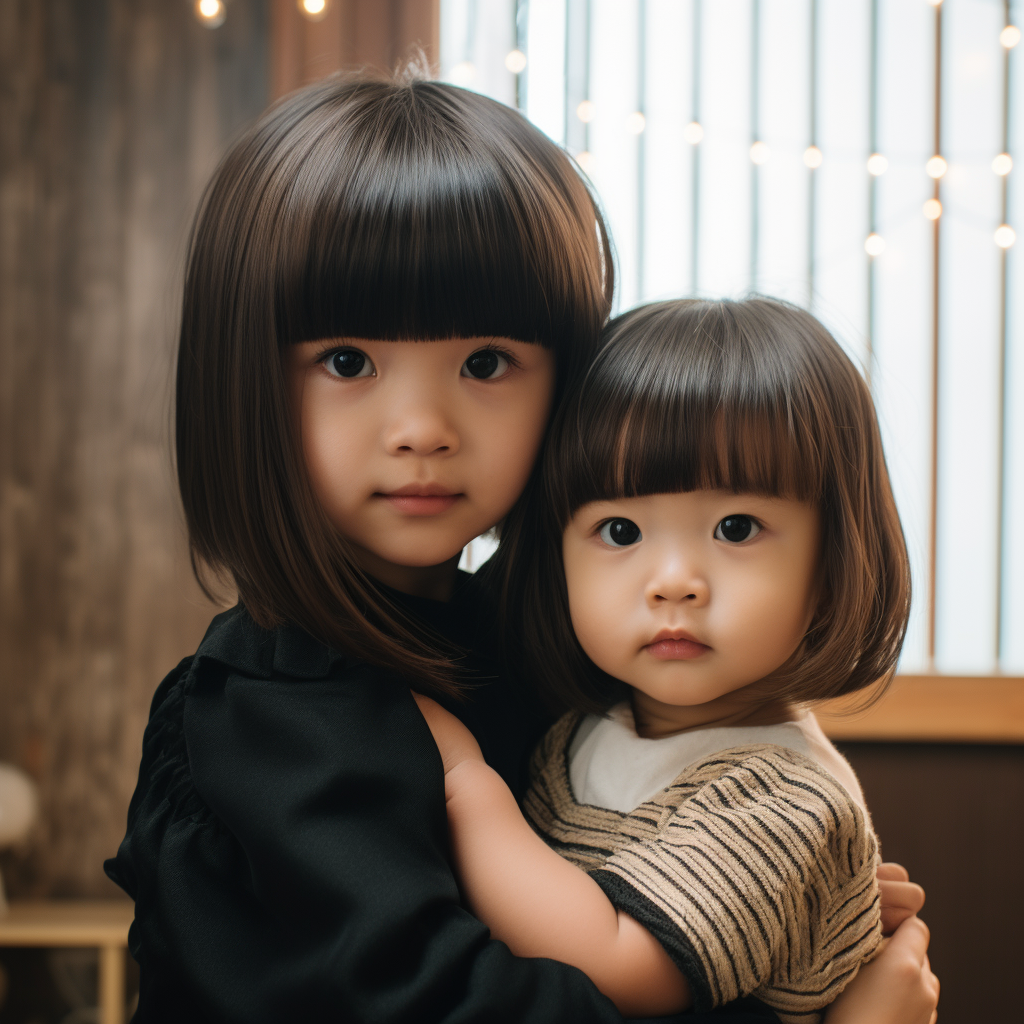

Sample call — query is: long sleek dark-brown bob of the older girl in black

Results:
[175,74,613,693]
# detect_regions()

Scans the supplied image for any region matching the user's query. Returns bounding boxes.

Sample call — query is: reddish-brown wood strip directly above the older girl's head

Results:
[270,0,440,99]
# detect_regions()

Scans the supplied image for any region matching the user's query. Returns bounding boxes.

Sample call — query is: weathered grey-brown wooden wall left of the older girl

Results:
[0,0,269,897]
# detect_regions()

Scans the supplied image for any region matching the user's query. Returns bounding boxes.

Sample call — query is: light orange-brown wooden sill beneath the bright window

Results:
[815,676,1024,743]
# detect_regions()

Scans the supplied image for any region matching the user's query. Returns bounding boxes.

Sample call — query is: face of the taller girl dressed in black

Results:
[285,338,555,596]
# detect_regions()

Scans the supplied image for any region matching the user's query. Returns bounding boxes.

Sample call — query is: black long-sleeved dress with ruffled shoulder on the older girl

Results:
[105,581,774,1024]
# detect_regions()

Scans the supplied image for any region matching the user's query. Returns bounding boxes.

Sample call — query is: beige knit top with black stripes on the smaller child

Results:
[523,713,882,1024]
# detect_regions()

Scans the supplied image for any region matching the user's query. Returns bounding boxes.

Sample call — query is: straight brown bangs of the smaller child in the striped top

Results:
[546,300,856,527]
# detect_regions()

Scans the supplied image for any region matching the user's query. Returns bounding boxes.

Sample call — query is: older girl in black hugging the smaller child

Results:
[108,68,927,1024]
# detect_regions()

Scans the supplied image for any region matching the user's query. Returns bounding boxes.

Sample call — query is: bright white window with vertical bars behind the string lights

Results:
[441,0,1024,675]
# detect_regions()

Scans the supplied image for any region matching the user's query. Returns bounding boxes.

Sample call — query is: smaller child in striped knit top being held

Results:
[411,299,925,1021]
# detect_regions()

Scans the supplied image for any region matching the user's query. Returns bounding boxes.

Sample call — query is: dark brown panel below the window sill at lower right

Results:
[843,742,1024,1024]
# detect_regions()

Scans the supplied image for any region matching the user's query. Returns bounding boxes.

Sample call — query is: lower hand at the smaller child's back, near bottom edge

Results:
[825,918,939,1024]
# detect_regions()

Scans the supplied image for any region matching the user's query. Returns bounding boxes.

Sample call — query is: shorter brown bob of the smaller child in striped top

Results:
[494,298,910,713]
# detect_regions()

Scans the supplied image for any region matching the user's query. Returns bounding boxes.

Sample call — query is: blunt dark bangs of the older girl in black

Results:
[274,81,611,349]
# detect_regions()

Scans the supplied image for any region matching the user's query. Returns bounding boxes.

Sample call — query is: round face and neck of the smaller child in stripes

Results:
[562,490,820,735]
